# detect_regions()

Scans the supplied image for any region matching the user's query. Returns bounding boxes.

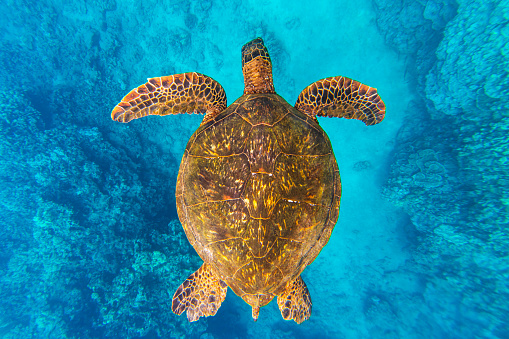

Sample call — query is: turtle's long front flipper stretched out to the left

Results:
[111,72,227,122]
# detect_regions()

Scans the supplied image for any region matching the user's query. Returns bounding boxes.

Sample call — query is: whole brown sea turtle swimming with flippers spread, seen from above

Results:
[111,38,385,324]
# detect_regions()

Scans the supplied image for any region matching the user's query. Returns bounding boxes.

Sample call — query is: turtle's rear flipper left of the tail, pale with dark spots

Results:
[171,263,228,321]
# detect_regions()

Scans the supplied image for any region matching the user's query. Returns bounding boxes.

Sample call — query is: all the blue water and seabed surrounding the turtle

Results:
[0,0,509,338]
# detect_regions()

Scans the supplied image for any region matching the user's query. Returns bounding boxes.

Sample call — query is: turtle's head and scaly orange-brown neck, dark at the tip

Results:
[242,38,276,94]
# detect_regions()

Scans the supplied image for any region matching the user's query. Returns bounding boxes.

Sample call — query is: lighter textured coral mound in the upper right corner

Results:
[425,1,509,119]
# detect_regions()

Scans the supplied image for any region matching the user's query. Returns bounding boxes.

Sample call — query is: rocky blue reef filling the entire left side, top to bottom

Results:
[0,1,207,338]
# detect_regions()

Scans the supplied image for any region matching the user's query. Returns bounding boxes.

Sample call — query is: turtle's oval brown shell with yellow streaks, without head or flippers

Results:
[176,94,341,306]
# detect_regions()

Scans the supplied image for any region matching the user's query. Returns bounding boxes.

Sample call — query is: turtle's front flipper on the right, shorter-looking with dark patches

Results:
[295,77,385,126]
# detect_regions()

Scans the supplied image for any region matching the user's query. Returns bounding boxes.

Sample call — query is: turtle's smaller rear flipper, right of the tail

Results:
[277,276,313,324]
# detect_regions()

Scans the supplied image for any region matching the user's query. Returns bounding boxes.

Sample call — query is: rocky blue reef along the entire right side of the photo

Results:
[374,0,509,337]
